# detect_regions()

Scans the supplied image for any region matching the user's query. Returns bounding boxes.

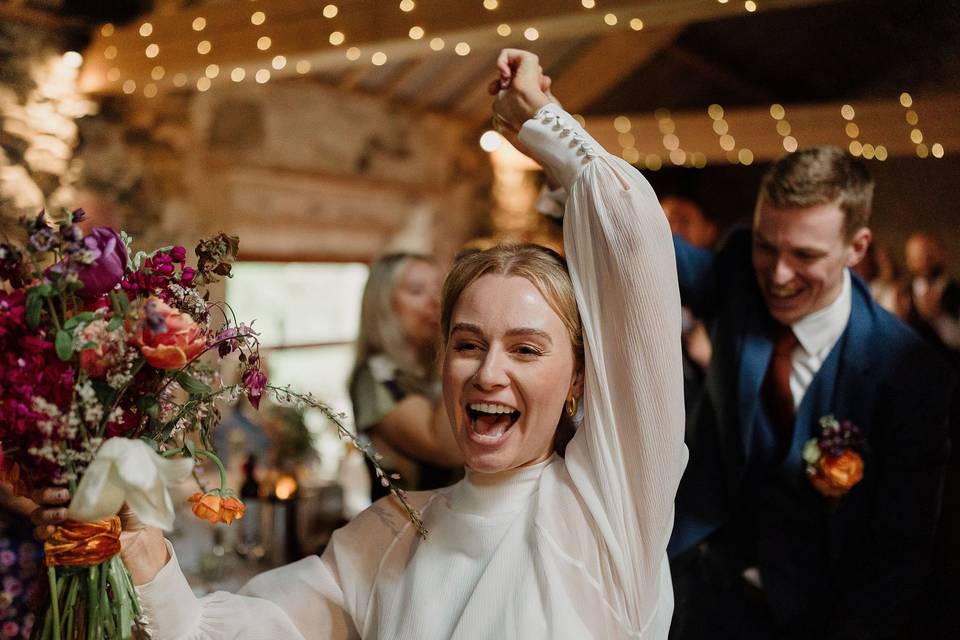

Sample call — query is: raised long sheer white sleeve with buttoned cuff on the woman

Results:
[520,104,687,635]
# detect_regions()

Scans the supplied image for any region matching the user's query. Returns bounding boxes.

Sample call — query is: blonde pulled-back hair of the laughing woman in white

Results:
[440,244,583,368]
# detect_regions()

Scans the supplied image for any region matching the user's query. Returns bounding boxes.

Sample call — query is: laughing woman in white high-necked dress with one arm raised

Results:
[116,49,686,640]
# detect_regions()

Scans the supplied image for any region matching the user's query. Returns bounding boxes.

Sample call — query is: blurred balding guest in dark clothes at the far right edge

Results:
[906,233,960,349]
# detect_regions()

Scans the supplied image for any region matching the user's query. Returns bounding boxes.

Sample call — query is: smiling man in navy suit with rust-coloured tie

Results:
[670,147,953,640]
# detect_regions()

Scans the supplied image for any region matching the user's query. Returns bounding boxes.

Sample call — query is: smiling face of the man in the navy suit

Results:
[753,203,870,325]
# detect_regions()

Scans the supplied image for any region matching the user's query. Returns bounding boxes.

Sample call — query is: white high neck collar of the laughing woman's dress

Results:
[450,454,557,516]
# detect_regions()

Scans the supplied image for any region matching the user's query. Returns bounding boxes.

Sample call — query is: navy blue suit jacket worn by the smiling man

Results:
[670,229,954,637]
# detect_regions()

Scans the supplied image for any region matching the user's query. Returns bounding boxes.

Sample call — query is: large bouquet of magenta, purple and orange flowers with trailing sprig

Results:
[0,209,422,640]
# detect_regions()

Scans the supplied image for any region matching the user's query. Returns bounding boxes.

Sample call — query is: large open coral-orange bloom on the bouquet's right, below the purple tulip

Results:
[133,298,207,369]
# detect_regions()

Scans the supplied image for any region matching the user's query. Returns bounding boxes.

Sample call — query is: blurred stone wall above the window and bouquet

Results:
[0,18,491,262]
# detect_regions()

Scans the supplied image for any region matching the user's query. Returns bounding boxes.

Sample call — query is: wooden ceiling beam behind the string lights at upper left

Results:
[81,0,835,93]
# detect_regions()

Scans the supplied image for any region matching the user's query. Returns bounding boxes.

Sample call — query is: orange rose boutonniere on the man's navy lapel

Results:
[803,416,864,498]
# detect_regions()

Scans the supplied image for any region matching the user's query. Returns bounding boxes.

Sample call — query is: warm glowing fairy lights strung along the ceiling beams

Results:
[75,0,944,171]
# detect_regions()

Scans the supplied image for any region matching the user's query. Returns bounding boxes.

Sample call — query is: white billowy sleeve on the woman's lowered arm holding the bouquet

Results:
[137,548,360,640]
